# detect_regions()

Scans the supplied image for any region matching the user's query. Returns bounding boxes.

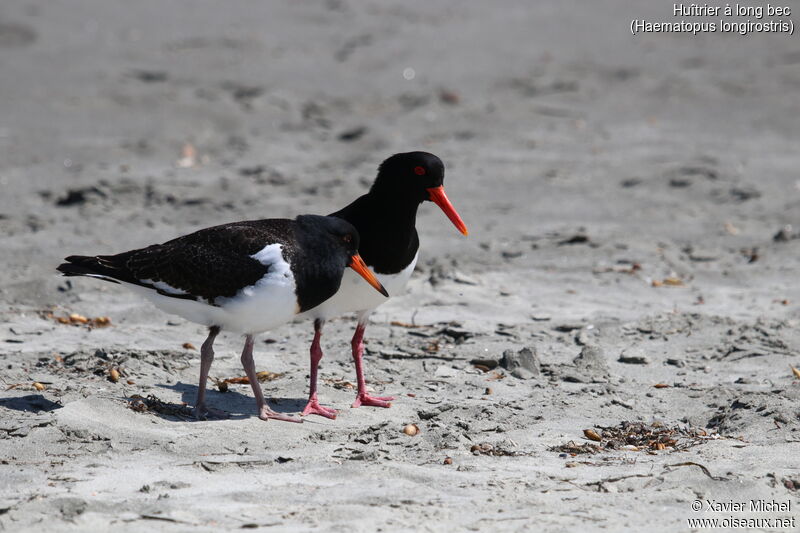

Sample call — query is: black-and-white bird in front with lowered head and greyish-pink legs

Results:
[58,215,388,422]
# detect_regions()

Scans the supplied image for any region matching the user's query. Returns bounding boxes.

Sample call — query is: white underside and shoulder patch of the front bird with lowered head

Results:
[125,244,298,334]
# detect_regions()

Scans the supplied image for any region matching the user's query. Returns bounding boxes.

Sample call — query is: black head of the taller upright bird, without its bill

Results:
[370,152,444,203]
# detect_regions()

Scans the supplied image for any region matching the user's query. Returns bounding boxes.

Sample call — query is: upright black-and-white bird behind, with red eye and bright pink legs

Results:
[301,152,467,418]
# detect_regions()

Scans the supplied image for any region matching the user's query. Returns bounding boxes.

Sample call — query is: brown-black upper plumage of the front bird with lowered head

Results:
[58,216,374,311]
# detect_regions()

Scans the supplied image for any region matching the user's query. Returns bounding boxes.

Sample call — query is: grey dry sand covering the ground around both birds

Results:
[0,0,800,531]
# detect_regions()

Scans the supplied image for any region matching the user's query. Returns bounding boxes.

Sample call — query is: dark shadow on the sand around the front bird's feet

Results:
[144,382,307,421]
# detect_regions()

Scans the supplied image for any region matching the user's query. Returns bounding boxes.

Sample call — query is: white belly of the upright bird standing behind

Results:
[299,254,419,320]
